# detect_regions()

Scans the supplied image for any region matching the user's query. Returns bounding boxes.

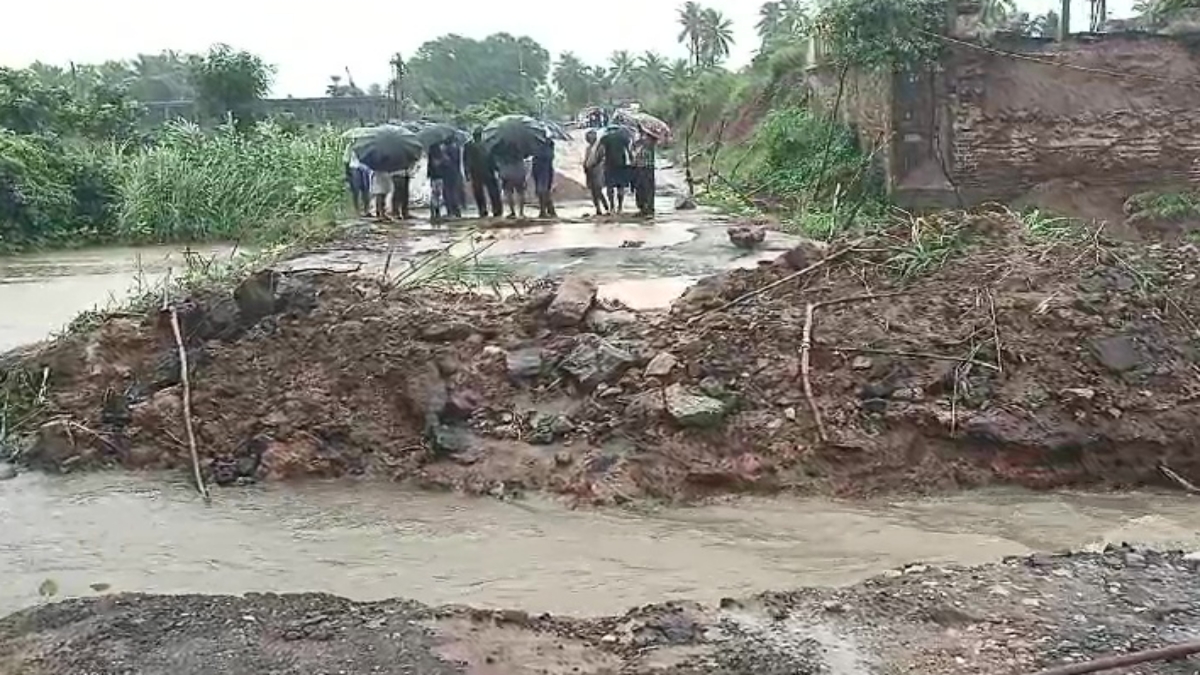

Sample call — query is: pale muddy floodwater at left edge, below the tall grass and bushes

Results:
[0,244,234,352]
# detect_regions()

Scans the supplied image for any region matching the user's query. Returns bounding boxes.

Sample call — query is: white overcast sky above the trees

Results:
[0,0,1133,96]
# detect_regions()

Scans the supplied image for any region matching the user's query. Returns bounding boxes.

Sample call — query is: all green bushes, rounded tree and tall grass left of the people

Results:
[0,44,344,253]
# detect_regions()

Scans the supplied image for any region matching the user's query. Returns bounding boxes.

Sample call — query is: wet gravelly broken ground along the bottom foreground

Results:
[0,546,1200,675]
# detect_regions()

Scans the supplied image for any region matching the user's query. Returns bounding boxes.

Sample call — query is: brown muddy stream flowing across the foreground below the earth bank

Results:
[0,473,1200,615]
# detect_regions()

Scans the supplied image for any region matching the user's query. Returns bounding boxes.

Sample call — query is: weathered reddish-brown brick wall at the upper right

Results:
[941,34,1200,202]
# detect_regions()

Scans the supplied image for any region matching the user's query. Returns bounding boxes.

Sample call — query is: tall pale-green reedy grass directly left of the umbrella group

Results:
[116,123,344,241]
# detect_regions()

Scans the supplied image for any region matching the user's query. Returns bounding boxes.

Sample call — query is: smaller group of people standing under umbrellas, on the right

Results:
[583,129,658,217]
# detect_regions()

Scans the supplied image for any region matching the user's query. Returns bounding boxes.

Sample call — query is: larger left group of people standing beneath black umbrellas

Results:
[346,129,557,222]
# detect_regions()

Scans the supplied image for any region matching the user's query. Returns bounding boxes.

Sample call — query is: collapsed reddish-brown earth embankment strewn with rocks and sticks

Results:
[7,214,1200,502]
